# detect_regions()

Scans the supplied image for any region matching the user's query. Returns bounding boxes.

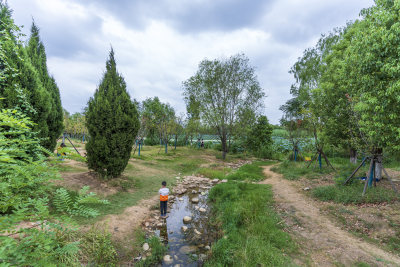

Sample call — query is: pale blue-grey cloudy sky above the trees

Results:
[8,0,373,123]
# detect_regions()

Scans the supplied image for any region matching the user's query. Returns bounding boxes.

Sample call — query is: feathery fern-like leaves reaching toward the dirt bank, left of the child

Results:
[53,186,110,217]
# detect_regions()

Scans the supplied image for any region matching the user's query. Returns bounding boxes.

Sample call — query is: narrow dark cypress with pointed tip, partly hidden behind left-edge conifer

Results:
[26,22,63,151]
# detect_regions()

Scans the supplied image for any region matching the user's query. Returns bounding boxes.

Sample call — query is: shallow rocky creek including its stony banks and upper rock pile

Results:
[141,176,225,267]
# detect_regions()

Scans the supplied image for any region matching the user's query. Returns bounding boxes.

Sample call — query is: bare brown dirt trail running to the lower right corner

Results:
[260,166,400,266]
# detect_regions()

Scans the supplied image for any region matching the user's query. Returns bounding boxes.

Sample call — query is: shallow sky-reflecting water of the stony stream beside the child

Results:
[155,185,217,266]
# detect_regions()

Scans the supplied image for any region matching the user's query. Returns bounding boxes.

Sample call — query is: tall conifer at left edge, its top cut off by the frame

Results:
[0,2,51,143]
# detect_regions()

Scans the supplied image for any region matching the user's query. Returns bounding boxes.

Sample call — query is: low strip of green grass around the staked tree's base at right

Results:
[312,183,398,204]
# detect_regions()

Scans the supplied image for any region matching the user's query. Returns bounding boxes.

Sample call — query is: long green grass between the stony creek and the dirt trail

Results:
[205,182,296,266]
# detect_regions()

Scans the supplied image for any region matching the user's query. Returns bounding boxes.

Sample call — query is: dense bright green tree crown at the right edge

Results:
[330,0,400,152]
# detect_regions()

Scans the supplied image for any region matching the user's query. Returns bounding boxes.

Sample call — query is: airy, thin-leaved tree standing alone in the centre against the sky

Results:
[183,54,264,159]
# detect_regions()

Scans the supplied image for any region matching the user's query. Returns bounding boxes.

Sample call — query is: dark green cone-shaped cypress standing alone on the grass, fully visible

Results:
[86,48,139,178]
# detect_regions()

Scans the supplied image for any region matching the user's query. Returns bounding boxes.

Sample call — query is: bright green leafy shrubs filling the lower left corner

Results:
[0,109,78,266]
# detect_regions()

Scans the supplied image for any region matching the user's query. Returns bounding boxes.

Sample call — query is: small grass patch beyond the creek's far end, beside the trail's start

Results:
[226,161,274,181]
